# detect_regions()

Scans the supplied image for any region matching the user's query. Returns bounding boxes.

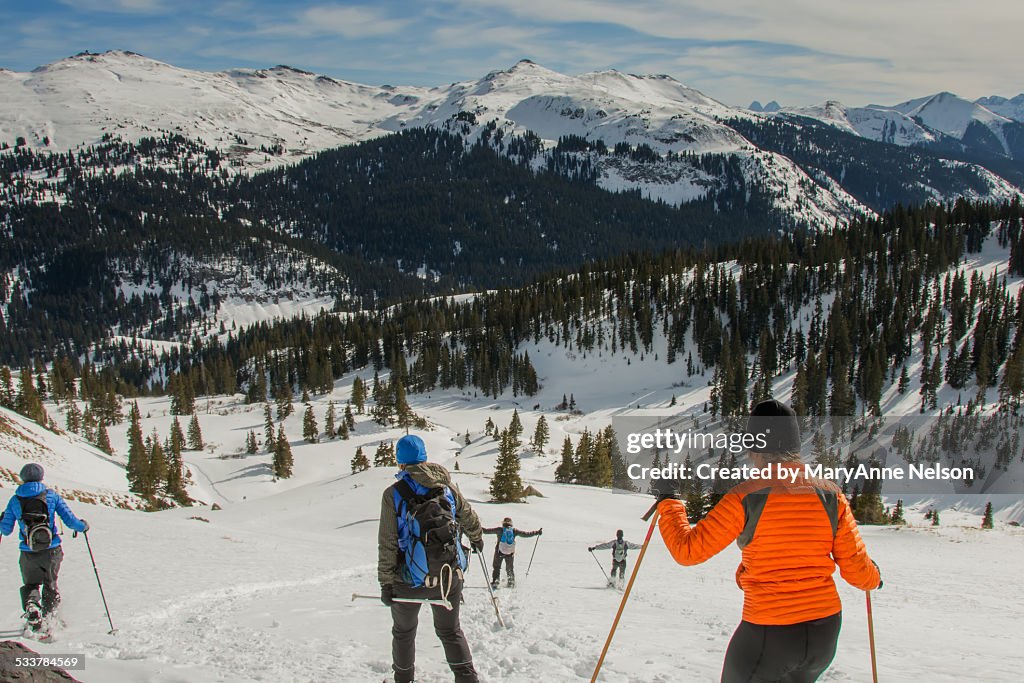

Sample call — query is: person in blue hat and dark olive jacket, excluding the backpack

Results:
[377,434,483,683]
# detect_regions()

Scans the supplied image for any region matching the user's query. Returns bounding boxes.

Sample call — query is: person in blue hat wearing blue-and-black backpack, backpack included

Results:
[377,434,483,683]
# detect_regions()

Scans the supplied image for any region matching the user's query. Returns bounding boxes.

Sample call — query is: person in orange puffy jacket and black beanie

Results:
[653,400,882,683]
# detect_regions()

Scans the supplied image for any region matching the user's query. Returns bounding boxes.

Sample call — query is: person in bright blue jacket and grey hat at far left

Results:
[0,463,89,631]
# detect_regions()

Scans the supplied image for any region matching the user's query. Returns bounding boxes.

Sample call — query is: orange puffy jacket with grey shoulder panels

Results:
[657,464,880,626]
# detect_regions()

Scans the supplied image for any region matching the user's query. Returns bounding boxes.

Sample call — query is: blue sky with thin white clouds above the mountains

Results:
[0,0,1024,104]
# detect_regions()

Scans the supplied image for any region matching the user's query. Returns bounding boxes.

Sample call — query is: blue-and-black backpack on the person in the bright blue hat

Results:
[392,475,468,588]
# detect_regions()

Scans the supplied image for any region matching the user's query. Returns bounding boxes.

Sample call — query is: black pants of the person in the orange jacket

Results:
[722,612,843,683]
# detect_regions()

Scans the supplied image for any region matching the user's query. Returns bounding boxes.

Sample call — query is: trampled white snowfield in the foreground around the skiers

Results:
[0,370,1024,683]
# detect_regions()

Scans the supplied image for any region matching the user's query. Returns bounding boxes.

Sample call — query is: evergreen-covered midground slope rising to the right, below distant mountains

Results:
[8,194,1024,428]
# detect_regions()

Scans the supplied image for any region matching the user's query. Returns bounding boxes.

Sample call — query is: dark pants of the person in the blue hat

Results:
[391,578,479,683]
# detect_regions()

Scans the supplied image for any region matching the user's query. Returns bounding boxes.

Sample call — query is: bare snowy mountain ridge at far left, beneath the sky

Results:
[0,50,422,167]
